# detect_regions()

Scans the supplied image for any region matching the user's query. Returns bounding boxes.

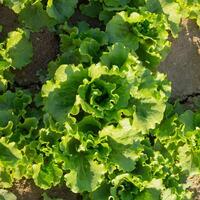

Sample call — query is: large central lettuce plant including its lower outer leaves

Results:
[42,50,170,192]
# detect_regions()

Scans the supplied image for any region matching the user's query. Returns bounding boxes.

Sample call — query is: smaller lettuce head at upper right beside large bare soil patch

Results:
[106,11,170,69]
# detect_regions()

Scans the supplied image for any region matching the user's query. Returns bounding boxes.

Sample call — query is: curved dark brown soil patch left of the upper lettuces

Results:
[14,30,59,87]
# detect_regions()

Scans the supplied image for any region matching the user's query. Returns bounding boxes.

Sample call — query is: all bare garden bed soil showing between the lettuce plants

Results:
[0,1,200,200]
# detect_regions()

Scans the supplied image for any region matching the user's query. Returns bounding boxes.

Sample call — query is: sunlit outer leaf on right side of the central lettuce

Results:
[131,69,171,132]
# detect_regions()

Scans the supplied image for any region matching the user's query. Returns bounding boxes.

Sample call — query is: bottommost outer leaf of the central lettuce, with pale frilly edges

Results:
[56,132,107,193]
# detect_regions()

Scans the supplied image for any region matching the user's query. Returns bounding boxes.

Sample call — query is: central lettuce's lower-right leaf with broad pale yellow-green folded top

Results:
[99,119,143,171]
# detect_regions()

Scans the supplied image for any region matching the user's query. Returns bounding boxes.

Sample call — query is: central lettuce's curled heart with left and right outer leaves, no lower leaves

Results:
[42,46,170,131]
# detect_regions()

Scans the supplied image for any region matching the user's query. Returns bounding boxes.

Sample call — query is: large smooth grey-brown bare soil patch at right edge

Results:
[160,20,200,99]
